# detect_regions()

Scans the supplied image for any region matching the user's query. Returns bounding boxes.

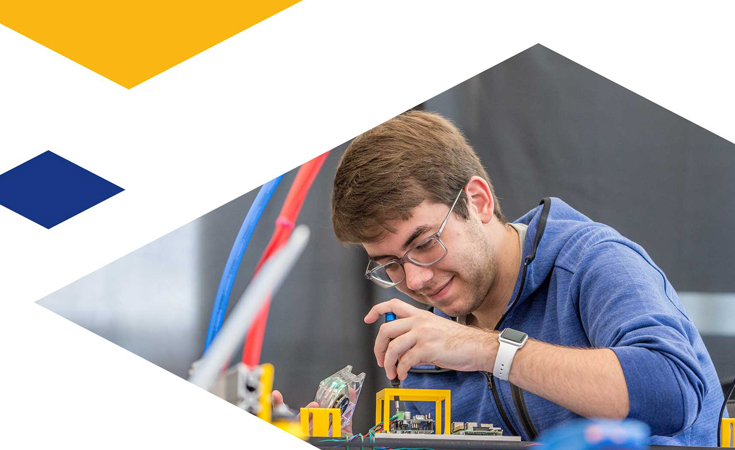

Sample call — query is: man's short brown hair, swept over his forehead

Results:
[332,111,505,244]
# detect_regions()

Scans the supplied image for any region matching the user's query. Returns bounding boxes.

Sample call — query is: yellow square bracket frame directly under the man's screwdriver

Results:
[375,388,452,434]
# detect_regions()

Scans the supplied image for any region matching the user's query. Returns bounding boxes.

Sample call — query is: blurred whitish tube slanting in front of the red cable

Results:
[189,225,309,389]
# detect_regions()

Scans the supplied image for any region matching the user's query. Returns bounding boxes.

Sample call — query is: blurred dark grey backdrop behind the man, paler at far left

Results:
[39,45,735,430]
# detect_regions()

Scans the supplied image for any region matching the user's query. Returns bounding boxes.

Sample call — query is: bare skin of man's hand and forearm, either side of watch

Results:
[365,299,629,419]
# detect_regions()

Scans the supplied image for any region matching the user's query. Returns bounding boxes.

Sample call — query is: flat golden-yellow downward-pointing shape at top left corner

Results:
[0,0,299,88]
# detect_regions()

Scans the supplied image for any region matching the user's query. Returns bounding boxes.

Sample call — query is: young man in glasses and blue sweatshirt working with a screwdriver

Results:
[332,111,723,445]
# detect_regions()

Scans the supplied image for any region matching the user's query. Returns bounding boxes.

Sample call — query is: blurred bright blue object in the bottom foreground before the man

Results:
[538,419,651,450]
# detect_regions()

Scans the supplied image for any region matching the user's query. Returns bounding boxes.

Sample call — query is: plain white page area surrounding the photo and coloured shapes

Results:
[0,0,735,448]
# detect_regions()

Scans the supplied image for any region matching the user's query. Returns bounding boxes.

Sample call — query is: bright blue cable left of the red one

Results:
[204,175,283,352]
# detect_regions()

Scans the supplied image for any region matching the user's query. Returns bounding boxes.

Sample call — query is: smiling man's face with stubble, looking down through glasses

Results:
[363,201,498,317]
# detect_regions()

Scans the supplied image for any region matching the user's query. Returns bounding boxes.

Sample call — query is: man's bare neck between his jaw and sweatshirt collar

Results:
[467,224,522,329]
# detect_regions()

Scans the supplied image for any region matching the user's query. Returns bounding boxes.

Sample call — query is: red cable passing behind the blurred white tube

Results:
[242,152,329,367]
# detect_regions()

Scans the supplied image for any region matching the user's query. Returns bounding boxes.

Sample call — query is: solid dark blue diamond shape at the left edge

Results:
[0,151,124,228]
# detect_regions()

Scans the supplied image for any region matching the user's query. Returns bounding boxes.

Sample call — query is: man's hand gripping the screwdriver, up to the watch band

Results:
[365,299,498,380]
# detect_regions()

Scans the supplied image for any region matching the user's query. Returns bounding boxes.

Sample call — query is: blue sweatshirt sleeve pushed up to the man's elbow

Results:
[573,242,707,436]
